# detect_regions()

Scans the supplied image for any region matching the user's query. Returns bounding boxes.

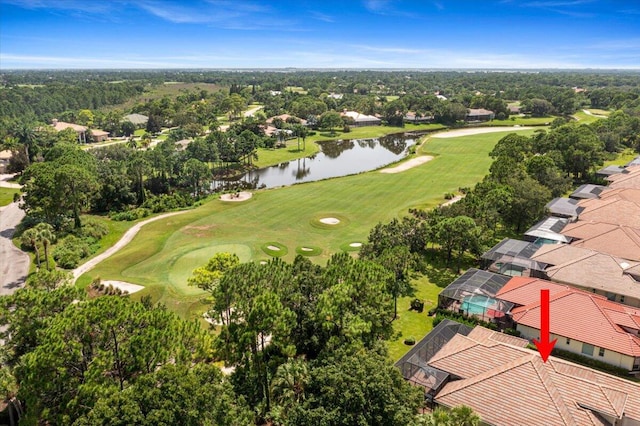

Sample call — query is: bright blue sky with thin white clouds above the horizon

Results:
[0,0,640,69]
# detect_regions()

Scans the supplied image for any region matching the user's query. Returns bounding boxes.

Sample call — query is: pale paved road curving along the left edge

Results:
[0,203,30,296]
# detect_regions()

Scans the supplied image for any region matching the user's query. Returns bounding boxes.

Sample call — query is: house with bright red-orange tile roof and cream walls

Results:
[496,277,640,374]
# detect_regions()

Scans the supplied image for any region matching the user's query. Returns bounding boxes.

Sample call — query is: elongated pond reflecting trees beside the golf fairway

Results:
[215,134,415,188]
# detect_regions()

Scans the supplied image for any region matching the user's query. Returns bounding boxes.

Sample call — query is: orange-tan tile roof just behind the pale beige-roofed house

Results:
[562,221,640,261]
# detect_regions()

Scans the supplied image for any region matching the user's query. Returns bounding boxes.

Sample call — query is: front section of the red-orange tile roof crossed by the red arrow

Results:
[511,289,640,357]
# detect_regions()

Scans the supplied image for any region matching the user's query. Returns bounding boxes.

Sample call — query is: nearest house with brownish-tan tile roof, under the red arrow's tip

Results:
[400,324,640,426]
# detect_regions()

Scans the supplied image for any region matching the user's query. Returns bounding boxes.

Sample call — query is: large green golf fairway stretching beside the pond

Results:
[79,130,533,320]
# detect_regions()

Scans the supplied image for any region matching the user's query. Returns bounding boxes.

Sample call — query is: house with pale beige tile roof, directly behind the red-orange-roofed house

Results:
[532,244,640,307]
